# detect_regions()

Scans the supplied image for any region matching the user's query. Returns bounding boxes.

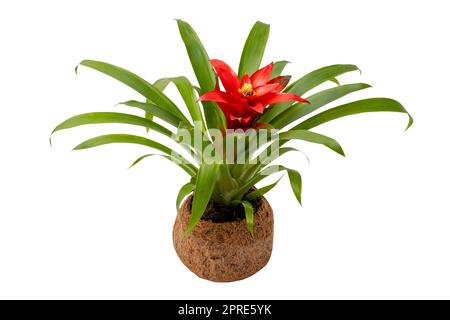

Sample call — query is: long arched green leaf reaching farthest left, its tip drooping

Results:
[52,112,172,137]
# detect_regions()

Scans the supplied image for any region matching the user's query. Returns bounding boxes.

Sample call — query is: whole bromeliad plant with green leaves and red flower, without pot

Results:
[53,20,413,236]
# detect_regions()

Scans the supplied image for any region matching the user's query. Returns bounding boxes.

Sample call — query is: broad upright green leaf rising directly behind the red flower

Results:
[238,21,270,79]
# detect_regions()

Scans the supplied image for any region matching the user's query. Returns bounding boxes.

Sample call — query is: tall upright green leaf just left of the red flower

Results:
[177,20,226,130]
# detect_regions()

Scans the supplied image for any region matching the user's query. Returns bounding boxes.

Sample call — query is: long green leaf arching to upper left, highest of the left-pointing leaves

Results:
[76,60,189,123]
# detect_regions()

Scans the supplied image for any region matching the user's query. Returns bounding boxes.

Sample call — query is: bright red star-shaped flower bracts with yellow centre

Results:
[199,60,308,129]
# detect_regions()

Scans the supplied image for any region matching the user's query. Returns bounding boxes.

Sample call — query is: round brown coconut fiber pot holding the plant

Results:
[173,195,273,282]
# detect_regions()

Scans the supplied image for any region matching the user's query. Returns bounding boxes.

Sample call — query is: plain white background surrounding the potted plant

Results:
[0,0,450,299]
